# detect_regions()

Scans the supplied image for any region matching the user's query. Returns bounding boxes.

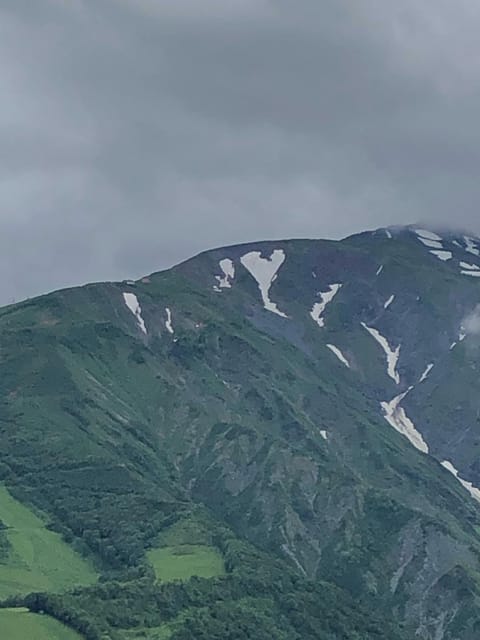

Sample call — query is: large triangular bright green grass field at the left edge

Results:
[0,485,97,600]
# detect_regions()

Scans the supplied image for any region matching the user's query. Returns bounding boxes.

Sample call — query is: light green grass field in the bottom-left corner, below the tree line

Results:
[0,609,81,640]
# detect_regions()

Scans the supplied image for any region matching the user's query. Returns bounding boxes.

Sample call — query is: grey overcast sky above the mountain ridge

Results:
[0,0,480,303]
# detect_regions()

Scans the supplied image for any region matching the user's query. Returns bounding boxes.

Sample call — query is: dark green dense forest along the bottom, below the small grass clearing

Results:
[3,526,402,640]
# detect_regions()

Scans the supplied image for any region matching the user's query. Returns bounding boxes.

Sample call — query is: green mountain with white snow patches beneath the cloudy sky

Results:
[0,225,480,640]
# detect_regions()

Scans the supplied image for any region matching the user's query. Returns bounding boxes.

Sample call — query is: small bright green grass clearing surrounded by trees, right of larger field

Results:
[147,544,225,582]
